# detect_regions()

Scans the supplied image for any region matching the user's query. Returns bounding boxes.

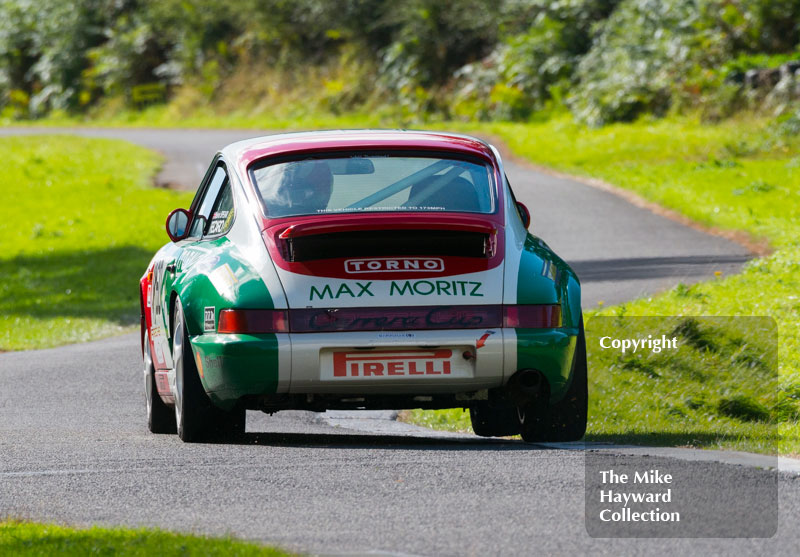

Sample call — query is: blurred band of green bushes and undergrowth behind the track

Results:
[0,0,800,126]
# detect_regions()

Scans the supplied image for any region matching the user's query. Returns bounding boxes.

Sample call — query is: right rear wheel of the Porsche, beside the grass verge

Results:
[518,316,589,442]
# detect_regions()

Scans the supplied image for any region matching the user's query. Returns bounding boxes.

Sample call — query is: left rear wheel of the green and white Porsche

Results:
[172,300,246,443]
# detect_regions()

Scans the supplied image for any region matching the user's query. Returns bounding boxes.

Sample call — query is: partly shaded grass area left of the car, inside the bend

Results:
[0,136,190,350]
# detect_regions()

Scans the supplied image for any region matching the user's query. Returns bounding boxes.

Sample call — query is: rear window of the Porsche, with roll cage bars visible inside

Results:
[250,153,496,217]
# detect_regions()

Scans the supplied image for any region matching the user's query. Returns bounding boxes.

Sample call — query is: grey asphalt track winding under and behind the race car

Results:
[0,130,800,556]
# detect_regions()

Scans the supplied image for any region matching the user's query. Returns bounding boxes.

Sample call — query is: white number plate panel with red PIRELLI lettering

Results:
[320,346,475,381]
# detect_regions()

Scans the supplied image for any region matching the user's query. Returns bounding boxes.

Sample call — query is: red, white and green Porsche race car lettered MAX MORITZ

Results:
[140,131,587,441]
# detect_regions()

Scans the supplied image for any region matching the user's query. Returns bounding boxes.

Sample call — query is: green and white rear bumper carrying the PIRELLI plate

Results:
[191,329,577,408]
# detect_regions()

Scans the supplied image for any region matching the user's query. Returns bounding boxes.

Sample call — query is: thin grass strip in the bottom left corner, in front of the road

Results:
[0,521,291,557]
